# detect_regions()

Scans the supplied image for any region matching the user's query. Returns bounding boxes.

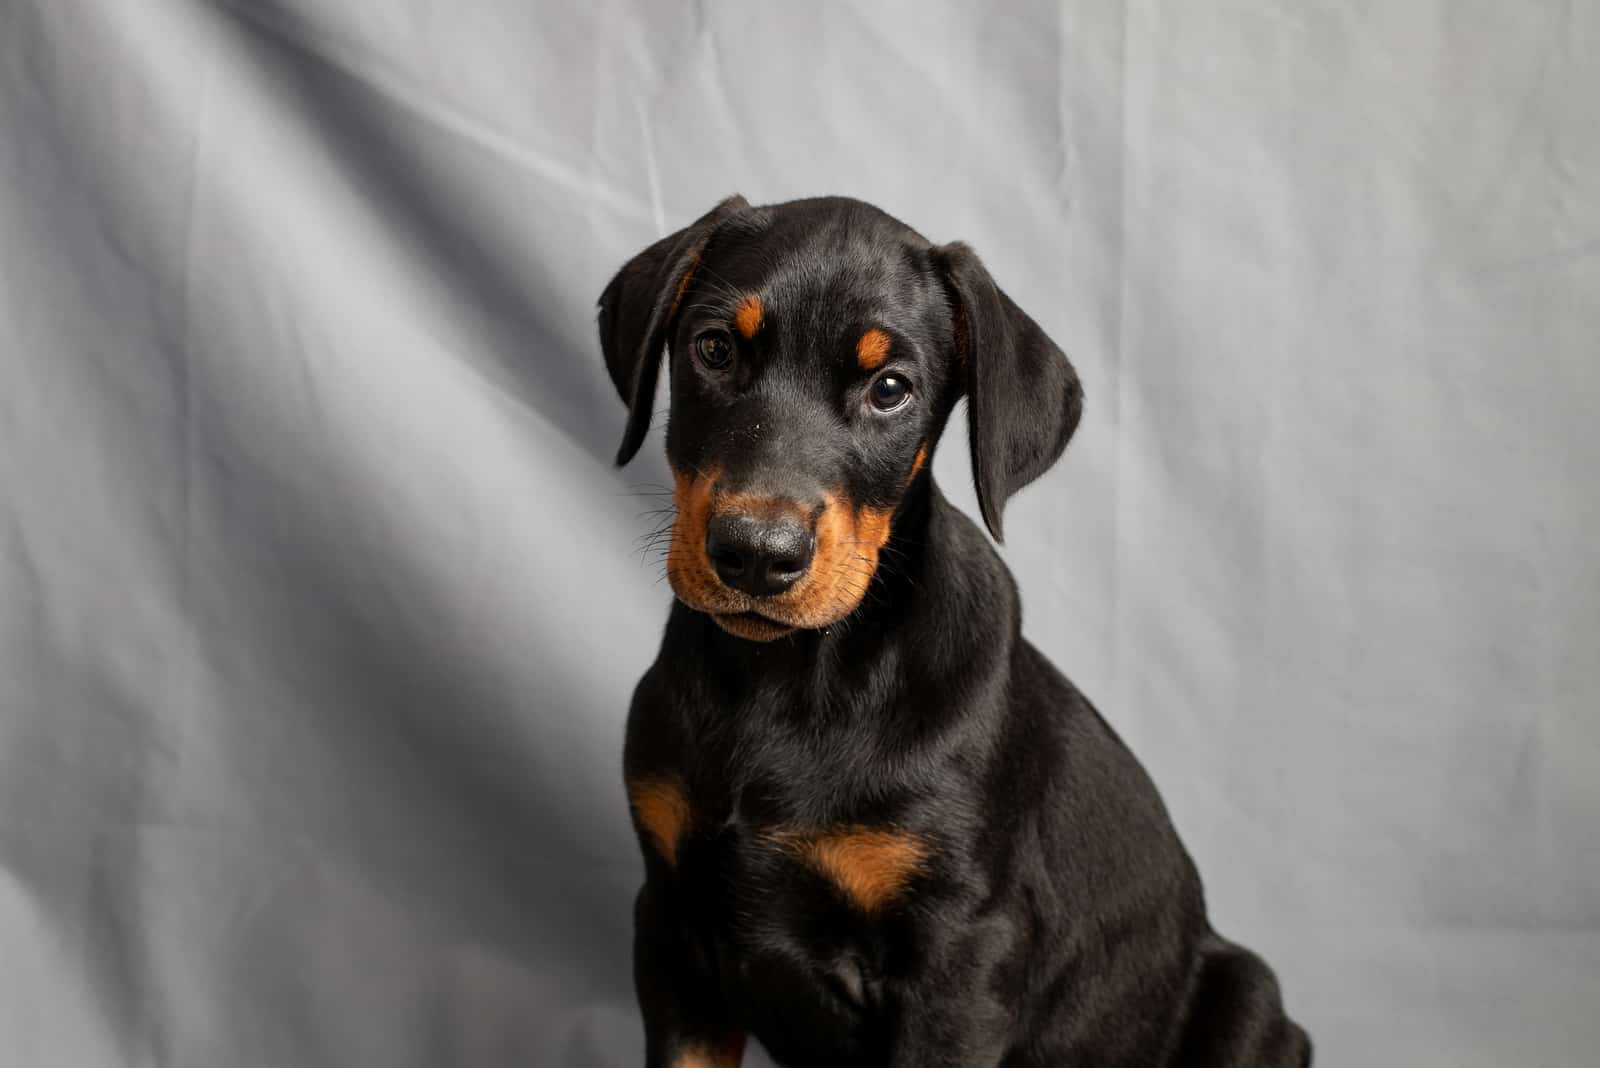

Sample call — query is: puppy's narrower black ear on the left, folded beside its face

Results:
[600,195,750,467]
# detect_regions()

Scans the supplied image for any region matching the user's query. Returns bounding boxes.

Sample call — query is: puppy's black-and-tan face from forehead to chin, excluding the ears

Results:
[667,213,952,640]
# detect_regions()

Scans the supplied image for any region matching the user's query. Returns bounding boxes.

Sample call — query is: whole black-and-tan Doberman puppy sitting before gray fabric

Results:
[600,197,1310,1068]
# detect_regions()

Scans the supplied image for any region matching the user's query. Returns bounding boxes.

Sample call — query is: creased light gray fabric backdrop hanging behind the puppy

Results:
[0,0,1600,1068]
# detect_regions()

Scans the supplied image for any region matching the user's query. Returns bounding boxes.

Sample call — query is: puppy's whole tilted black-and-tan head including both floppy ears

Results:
[600,197,1083,640]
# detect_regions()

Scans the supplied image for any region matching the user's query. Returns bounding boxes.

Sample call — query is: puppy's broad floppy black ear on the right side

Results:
[934,241,1083,542]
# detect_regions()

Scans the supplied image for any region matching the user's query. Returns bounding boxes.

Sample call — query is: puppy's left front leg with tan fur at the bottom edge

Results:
[634,881,744,1068]
